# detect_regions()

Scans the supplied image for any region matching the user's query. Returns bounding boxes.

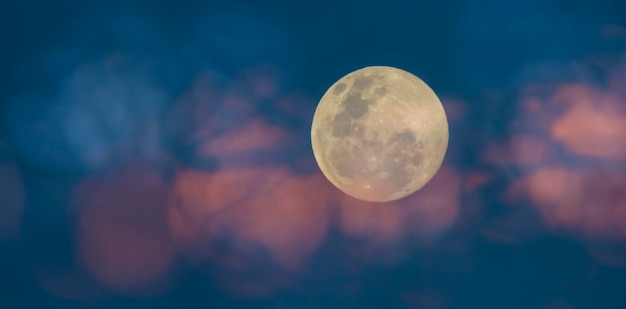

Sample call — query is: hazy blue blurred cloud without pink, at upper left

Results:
[7,55,166,172]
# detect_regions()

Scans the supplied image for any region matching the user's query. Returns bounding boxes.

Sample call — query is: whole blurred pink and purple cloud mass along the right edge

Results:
[483,49,626,265]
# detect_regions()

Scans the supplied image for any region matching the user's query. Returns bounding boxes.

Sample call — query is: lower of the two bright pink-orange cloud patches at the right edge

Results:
[504,166,626,239]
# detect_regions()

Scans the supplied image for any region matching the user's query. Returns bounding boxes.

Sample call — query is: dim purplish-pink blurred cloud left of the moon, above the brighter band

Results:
[166,62,315,168]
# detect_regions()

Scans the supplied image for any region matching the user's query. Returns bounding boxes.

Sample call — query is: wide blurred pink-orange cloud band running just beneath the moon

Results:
[169,161,462,295]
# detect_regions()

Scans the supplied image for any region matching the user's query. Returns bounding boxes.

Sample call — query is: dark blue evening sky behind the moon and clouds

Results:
[0,0,626,308]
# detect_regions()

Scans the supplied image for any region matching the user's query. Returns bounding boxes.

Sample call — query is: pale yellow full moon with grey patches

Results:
[311,66,448,202]
